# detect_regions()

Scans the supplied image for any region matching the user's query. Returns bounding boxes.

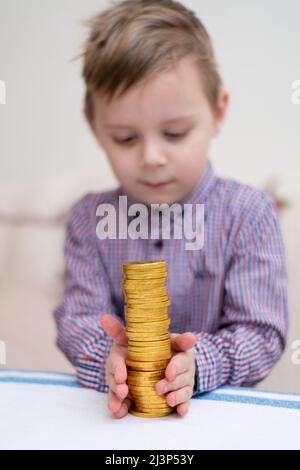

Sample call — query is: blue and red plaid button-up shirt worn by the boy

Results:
[54,163,288,394]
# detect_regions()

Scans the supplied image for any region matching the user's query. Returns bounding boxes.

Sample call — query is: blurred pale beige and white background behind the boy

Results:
[0,0,300,392]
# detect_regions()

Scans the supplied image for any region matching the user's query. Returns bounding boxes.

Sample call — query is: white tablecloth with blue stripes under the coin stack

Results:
[0,369,300,450]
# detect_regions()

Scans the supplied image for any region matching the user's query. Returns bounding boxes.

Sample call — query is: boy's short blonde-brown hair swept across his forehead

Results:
[77,0,222,118]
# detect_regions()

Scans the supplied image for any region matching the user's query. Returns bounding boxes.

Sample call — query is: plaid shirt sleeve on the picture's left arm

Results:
[54,194,116,392]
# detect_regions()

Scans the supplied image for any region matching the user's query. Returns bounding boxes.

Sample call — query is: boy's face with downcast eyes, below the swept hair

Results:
[85,58,228,204]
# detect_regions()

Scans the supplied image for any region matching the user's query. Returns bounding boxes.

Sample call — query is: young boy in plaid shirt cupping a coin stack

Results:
[55,0,287,418]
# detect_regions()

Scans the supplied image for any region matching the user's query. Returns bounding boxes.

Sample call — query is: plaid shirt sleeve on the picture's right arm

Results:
[194,197,288,395]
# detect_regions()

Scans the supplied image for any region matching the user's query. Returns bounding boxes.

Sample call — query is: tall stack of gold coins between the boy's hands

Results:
[122,260,173,418]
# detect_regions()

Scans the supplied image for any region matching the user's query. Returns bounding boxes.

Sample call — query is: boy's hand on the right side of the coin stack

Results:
[155,333,197,416]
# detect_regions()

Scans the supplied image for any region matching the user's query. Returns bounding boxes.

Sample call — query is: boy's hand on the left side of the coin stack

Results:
[100,315,132,418]
